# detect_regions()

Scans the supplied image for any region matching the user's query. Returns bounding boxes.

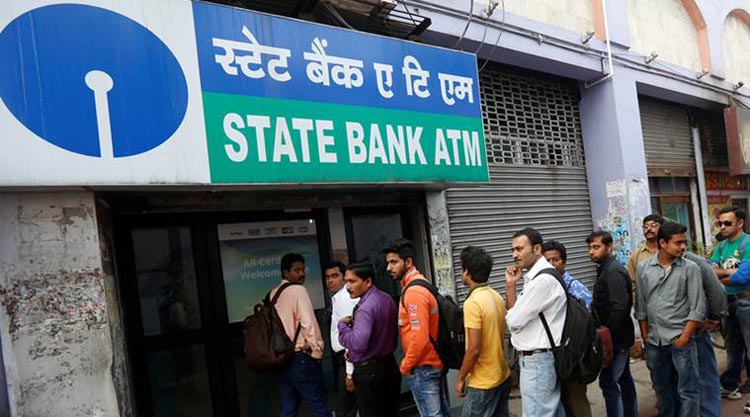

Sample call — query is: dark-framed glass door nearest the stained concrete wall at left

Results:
[121,224,222,417]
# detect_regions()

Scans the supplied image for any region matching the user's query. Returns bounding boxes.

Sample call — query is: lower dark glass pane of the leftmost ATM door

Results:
[146,345,213,417]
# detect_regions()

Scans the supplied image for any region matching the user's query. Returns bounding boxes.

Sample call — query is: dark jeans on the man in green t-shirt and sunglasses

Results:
[721,298,750,390]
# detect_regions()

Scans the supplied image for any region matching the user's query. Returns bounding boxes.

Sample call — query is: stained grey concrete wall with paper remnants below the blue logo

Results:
[0,193,119,417]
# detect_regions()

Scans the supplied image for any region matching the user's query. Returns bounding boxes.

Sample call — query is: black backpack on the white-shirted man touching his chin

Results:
[539,268,604,384]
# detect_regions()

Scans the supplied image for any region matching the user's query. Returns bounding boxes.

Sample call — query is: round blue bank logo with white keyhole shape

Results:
[0,4,188,158]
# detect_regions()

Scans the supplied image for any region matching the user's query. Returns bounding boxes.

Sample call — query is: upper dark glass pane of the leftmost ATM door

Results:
[132,227,201,336]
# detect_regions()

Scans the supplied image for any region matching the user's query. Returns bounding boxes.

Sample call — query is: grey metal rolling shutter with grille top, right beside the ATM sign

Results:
[446,66,596,302]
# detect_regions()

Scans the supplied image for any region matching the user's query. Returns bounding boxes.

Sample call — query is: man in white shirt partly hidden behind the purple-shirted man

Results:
[325,261,359,417]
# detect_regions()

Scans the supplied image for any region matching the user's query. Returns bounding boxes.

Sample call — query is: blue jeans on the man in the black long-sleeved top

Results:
[599,342,638,417]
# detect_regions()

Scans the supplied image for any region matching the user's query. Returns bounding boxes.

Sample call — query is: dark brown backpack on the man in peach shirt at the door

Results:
[244,282,300,372]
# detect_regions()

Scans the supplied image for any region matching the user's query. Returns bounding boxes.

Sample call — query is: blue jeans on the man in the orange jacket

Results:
[406,366,451,417]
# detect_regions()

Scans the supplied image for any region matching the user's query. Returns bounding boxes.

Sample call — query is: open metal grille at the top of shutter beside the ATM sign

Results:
[480,66,585,168]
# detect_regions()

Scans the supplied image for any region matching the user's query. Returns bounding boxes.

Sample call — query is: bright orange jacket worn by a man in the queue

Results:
[398,267,443,375]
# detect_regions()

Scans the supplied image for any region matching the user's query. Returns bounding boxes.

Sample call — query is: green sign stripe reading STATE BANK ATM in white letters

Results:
[203,92,489,183]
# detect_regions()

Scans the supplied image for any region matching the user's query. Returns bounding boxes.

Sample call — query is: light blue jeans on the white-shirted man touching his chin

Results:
[518,352,565,417]
